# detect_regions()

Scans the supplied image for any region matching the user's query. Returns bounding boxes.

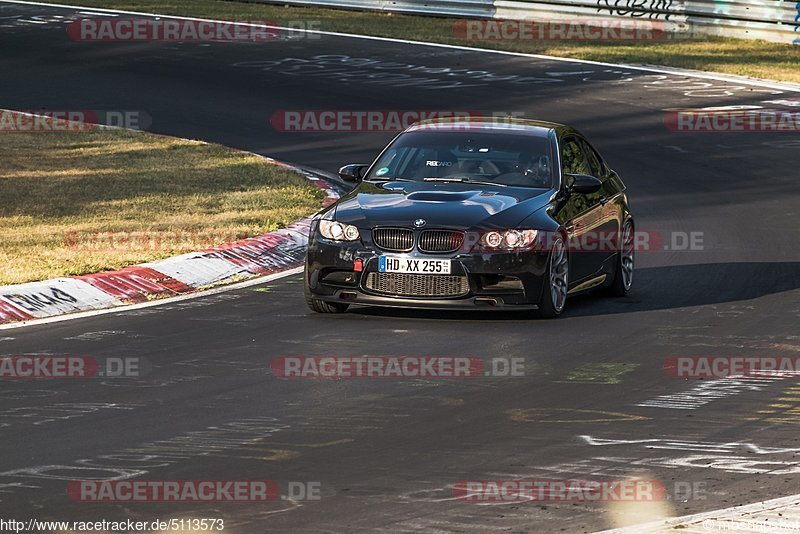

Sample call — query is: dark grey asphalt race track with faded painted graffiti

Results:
[0,3,800,533]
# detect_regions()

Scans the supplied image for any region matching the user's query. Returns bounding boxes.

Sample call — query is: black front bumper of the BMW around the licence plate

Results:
[306,231,547,310]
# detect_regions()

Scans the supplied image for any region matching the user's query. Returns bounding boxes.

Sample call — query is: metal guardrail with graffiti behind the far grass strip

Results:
[255,0,800,45]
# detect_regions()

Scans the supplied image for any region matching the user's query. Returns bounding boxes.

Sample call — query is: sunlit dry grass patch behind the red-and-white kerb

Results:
[0,112,325,284]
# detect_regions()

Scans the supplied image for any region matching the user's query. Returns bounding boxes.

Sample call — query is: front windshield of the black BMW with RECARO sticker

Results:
[366,131,553,188]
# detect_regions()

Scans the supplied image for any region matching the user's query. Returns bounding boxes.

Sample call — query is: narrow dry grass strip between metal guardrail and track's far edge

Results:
[42,0,800,82]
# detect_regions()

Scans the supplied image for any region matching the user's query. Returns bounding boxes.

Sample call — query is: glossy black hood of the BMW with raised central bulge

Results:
[335,182,553,229]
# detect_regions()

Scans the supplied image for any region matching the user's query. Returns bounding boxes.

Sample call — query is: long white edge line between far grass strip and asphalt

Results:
[0,0,800,93]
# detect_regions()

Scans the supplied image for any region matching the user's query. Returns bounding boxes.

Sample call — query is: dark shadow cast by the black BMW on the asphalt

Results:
[350,262,800,321]
